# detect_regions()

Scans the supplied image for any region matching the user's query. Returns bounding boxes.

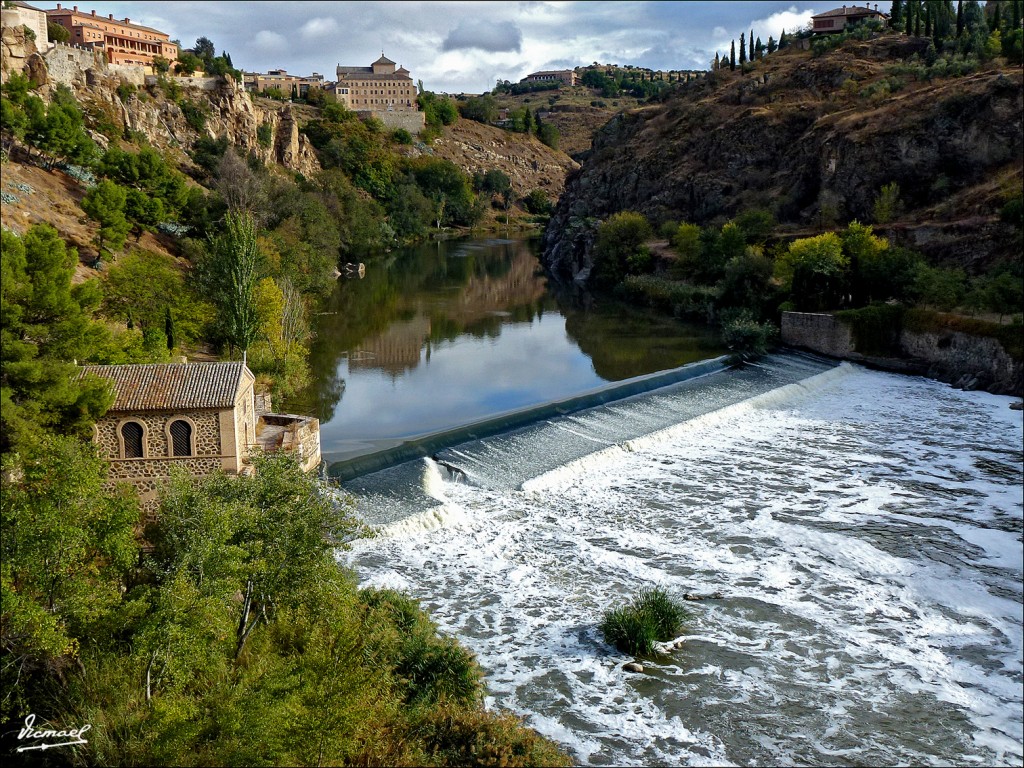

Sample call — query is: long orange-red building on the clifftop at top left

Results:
[46,3,178,67]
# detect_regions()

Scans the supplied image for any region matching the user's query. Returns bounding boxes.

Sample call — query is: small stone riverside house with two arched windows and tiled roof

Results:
[82,362,321,518]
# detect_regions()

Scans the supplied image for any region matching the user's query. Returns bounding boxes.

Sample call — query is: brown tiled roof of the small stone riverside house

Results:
[82,362,253,411]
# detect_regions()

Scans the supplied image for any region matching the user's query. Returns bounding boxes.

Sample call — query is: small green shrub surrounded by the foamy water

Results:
[600,587,689,655]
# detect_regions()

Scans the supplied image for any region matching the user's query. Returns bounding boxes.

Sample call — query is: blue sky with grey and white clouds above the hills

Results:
[59,0,851,93]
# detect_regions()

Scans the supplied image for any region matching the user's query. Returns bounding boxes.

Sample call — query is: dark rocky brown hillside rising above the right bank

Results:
[545,35,1024,278]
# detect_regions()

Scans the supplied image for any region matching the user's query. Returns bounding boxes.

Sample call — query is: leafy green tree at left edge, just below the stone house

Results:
[0,435,139,720]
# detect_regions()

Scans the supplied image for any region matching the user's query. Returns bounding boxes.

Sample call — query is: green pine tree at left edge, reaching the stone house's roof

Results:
[0,224,113,453]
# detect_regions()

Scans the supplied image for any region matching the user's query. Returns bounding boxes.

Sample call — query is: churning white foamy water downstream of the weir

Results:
[343,361,1024,765]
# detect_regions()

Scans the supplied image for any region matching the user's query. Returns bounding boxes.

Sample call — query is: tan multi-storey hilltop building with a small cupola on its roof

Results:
[333,54,424,133]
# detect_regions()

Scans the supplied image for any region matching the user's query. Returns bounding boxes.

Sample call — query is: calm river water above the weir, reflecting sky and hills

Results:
[285,234,722,459]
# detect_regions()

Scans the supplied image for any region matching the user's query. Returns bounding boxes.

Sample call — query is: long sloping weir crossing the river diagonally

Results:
[344,353,854,536]
